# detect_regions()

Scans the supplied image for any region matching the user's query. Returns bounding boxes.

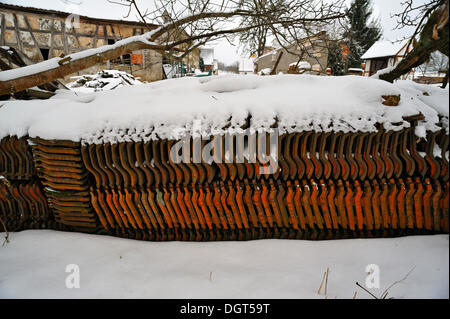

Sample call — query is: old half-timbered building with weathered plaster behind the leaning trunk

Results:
[0,3,200,82]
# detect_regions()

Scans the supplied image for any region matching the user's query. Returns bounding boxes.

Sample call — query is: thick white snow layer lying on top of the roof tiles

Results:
[0,75,449,143]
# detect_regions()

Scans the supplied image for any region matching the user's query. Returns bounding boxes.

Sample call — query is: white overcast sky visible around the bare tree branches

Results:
[0,0,429,64]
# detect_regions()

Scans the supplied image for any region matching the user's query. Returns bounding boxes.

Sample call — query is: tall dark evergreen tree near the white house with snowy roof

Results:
[344,0,382,68]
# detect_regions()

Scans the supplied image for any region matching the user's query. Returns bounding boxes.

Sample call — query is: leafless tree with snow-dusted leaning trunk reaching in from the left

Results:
[0,0,345,95]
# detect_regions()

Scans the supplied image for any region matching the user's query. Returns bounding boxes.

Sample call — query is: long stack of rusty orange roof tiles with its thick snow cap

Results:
[0,75,449,240]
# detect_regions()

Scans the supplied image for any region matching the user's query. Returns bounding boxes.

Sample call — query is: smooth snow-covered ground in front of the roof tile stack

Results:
[0,230,449,299]
